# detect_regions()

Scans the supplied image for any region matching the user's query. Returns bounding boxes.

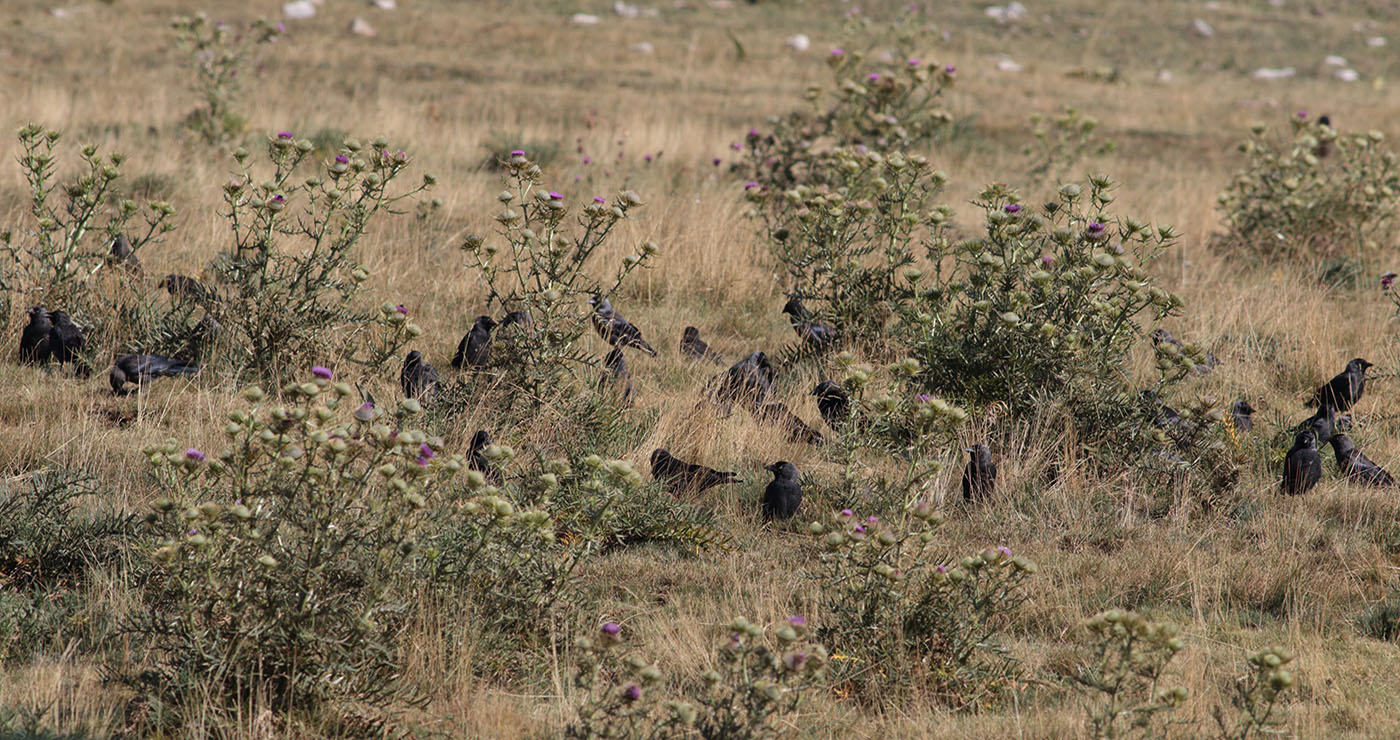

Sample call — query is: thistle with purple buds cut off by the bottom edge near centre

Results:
[564,617,827,740]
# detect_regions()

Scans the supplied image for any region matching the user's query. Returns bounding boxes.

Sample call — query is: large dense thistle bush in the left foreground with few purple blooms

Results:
[123,367,463,726]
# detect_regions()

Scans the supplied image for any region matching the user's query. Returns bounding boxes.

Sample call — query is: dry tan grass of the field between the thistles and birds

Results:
[0,0,1400,739]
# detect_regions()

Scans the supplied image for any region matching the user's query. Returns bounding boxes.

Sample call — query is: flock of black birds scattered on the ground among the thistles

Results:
[20,244,1377,519]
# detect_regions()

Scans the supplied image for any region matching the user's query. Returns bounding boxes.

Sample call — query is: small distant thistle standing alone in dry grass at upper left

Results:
[171,13,283,144]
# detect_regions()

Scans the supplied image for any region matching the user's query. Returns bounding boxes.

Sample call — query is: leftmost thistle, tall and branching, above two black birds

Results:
[0,123,175,325]
